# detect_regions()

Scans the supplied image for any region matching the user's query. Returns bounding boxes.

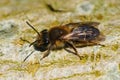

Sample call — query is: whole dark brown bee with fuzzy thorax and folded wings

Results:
[24,22,102,61]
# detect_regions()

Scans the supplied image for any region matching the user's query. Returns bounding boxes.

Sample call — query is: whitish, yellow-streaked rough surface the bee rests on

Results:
[0,0,120,80]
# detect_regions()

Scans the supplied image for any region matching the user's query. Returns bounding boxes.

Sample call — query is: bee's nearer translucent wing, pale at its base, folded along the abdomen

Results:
[62,31,105,42]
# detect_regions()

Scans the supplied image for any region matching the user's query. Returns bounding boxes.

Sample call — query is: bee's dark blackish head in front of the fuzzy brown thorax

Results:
[33,29,49,52]
